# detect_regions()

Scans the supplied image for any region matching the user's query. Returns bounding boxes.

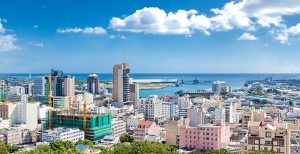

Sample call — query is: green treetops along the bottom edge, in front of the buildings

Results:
[0,140,275,154]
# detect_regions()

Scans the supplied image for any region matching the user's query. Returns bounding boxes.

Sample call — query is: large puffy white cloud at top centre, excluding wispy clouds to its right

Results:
[110,7,211,35]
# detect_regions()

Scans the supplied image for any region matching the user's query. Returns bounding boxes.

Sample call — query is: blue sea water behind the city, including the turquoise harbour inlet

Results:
[0,73,300,97]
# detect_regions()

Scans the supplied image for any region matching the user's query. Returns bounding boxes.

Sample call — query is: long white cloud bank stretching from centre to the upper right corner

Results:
[109,0,300,42]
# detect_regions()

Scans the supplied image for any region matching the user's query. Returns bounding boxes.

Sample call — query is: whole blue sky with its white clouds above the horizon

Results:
[0,0,300,73]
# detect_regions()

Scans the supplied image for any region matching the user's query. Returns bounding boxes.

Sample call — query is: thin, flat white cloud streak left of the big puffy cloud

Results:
[56,27,106,35]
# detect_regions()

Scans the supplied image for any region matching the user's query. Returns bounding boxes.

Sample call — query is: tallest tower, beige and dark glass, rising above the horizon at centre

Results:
[113,63,130,102]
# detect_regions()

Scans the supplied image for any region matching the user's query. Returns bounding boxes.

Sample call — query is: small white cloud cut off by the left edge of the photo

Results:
[0,19,18,52]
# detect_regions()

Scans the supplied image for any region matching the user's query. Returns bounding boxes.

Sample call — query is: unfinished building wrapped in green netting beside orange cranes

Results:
[52,110,112,143]
